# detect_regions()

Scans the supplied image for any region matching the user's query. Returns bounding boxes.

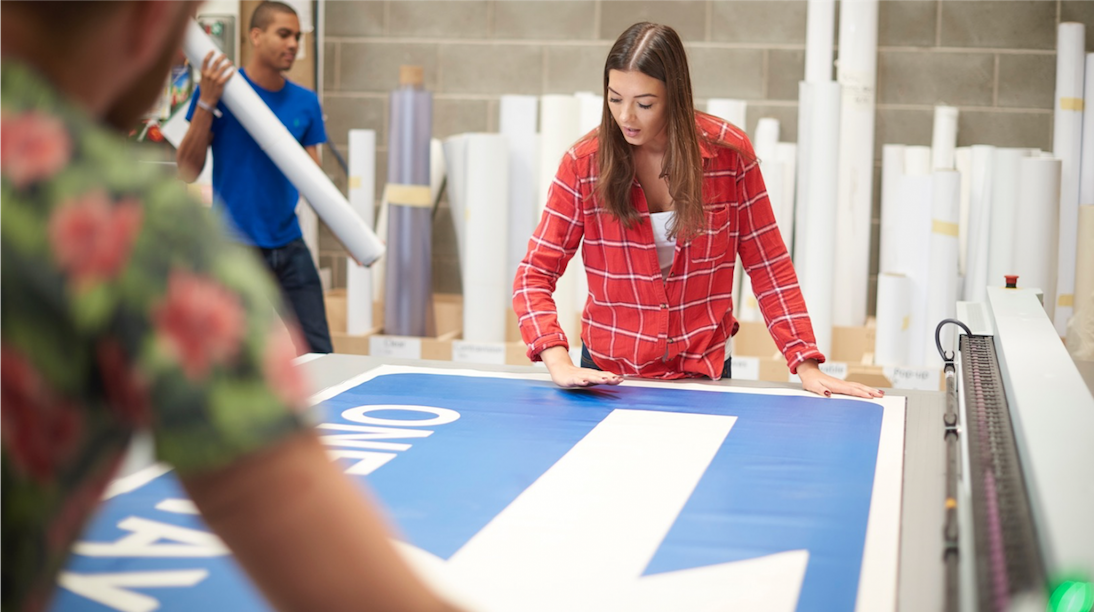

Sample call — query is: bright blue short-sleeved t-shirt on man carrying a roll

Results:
[186,68,327,249]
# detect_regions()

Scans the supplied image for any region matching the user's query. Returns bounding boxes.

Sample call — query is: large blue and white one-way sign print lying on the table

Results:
[53,367,904,612]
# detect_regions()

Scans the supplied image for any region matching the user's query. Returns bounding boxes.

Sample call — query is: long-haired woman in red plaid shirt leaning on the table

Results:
[513,23,882,397]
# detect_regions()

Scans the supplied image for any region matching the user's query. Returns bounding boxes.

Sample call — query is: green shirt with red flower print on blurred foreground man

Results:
[0,61,307,610]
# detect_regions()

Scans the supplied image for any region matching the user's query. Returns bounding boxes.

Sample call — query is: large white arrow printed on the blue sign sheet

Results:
[400,409,808,612]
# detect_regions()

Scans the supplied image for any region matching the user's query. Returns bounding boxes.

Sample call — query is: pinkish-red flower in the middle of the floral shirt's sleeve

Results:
[152,269,244,381]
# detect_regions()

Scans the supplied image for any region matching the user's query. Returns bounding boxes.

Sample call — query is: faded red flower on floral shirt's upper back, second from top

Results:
[49,192,143,289]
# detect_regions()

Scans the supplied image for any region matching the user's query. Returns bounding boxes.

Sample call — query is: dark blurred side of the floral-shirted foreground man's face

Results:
[105,0,201,130]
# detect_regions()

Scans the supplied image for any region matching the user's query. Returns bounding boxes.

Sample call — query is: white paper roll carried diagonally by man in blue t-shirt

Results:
[183,21,384,265]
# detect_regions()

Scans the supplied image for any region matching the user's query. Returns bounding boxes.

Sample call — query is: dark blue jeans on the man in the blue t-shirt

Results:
[259,238,334,353]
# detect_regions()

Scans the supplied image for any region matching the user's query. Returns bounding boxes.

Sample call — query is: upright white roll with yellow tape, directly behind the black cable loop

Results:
[912,170,961,367]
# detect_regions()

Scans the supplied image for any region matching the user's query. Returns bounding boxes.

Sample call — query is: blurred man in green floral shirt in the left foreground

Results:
[0,0,457,610]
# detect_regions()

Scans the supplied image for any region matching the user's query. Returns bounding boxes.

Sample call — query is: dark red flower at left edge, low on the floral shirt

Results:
[0,345,83,483]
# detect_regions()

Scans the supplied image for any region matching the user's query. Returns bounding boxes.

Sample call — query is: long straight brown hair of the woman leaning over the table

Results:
[597,22,706,239]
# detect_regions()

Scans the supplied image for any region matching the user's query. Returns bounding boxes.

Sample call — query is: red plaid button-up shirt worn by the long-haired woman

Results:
[513,113,824,379]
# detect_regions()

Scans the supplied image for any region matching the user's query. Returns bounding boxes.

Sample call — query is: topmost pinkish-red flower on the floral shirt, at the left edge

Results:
[0,111,72,189]
